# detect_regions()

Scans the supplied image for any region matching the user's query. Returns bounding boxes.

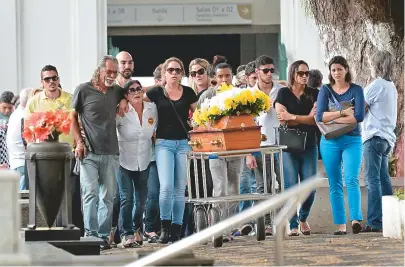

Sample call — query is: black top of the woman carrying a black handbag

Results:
[274,87,319,148]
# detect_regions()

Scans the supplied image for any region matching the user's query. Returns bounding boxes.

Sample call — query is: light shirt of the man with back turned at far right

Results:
[361,77,398,148]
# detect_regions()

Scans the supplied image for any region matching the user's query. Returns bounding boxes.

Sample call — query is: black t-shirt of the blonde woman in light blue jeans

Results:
[146,86,197,140]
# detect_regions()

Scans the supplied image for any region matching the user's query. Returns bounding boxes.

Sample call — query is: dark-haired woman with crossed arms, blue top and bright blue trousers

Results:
[316,56,365,235]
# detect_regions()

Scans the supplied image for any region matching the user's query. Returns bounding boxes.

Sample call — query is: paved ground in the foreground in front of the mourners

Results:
[102,233,404,266]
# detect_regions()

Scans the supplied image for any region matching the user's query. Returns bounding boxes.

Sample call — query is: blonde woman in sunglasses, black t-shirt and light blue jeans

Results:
[144,57,197,244]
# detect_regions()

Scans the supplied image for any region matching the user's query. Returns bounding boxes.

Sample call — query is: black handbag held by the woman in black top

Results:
[275,123,307,153]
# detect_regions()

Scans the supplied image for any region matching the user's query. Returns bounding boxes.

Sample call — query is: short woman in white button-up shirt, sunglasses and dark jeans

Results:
[117,80,158,248]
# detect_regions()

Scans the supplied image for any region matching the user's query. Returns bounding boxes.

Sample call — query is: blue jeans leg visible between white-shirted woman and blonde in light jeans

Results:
[145,161,160,233]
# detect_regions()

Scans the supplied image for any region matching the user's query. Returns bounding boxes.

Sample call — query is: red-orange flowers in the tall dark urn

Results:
[23,110,72,142]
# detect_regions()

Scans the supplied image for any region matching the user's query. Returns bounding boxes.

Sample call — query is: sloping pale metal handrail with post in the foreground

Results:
[126,177,326,267]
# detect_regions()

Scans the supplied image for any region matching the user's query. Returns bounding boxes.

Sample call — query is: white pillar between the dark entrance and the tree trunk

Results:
[280,0,329,82]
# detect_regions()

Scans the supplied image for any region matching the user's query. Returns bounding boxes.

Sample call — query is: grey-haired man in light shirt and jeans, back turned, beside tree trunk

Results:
[361,51,398,232]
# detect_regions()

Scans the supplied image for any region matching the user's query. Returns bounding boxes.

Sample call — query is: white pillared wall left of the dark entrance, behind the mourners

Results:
[0,0,107,92]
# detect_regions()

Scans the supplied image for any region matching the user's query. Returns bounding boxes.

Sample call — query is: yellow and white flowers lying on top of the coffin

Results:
[193,84,271,126]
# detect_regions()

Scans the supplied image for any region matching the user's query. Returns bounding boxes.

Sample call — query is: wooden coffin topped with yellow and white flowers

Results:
[189,84,271,152]
